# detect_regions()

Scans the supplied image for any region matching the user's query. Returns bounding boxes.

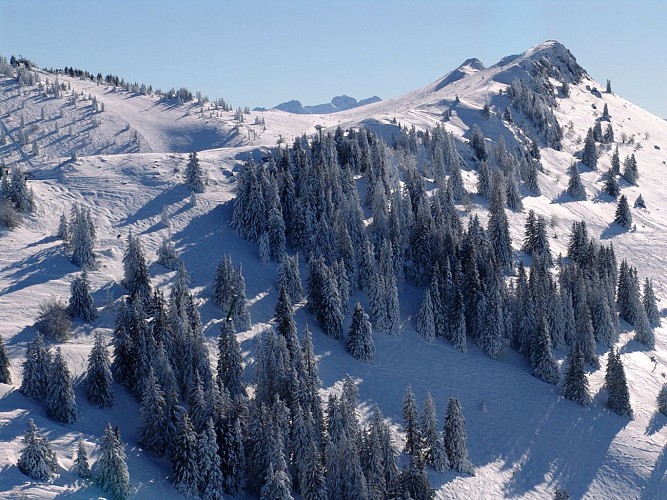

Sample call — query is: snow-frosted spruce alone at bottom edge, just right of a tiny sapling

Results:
[95,424,130,500]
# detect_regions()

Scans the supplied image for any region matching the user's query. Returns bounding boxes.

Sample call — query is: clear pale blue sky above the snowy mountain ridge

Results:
[0,0,667,118]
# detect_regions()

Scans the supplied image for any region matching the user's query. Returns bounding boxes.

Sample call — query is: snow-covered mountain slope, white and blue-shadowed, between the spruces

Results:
[0,41,667,499]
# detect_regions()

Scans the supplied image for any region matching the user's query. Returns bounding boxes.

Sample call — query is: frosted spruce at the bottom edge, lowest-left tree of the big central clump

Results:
[171,413,200,497]
